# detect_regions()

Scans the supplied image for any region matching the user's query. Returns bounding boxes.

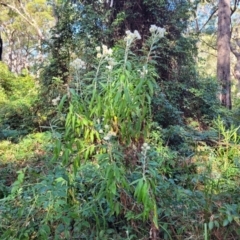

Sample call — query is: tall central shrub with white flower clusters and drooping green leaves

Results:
[53,25,165,235]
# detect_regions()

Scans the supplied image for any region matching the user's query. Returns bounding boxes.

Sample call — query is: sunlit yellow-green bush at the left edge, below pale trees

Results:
[0,63,38,141]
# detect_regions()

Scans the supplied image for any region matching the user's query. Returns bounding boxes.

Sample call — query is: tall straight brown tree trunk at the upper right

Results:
[217,0,232,109]
